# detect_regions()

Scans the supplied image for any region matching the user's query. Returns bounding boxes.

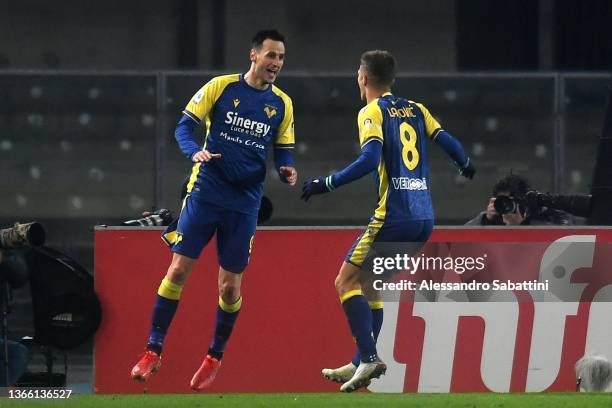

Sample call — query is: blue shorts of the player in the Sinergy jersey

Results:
[162,196,257,273]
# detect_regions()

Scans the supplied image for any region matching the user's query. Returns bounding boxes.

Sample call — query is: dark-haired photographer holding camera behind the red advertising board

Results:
[465,174,591,226]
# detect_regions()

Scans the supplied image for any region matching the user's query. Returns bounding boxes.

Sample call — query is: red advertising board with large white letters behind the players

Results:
[94,228,612,393]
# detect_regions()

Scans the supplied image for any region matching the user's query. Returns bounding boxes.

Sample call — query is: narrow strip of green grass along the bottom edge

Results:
[0,392,612,408]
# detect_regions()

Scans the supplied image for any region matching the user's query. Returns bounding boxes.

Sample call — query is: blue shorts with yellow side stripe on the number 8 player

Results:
[344,217,434,267]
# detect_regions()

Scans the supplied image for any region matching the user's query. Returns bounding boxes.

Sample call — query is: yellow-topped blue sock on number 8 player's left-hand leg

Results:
[340,290,378,363]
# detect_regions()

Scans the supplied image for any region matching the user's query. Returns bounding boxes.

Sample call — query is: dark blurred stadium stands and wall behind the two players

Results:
[0,0,612,396]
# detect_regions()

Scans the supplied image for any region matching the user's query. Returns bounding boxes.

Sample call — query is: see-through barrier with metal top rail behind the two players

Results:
[0,71,610,224]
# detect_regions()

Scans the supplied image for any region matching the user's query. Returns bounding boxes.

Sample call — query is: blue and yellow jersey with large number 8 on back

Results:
[357,93,441,220]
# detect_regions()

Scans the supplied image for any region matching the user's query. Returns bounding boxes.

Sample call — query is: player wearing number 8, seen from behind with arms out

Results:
[302,50,475,392]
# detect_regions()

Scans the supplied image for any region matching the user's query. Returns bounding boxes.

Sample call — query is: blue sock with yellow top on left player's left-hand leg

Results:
[147,278,183,354]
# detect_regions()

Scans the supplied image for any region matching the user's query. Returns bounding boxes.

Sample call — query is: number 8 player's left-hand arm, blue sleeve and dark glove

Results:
[302,139,382,201]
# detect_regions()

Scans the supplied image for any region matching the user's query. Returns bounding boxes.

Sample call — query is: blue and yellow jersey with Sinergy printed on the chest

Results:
[183,74,295,213]
